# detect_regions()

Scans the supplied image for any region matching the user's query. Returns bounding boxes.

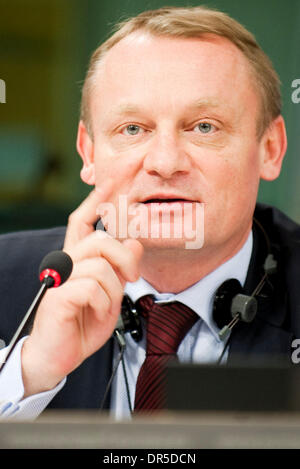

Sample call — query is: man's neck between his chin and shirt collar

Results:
[141,226,251,293]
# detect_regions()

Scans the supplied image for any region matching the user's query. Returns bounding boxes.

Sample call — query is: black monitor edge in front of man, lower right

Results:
[166,363,300,412]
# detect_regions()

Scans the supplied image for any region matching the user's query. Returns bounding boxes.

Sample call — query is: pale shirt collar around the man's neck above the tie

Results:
[125,230,253,338]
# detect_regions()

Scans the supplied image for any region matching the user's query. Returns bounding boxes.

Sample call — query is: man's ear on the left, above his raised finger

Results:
[76,121,96,186]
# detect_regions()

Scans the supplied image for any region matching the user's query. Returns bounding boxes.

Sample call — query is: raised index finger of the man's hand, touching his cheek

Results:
[64,178,114,249]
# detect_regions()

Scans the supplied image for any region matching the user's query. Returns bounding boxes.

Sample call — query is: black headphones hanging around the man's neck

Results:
[116,218,277,342]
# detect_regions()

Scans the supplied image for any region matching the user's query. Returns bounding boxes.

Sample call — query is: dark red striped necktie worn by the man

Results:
[134,295,199,413]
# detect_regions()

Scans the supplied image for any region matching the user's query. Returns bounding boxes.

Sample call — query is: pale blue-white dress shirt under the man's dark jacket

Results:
[0,231,253,420]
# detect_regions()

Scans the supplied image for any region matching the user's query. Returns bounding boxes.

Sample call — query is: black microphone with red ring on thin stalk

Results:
[0,251,73,372]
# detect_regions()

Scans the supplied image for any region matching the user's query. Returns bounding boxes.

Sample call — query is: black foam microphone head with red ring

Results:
[39,251,73,288]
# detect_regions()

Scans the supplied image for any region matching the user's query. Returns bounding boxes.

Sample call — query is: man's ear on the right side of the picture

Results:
[260,115,287,181]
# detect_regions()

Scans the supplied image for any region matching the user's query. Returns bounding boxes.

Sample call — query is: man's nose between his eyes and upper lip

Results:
[144,132,190,179]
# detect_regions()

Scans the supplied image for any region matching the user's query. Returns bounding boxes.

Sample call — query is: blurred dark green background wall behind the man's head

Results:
[0,0,300,232]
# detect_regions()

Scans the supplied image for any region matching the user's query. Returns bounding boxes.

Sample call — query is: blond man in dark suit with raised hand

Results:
[0,7,300,418]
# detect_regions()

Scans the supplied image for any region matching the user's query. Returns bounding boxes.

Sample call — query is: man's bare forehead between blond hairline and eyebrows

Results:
[91,32,257,120]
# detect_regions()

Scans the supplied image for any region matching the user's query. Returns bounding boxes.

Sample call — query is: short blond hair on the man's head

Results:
[80,6,281,139]
